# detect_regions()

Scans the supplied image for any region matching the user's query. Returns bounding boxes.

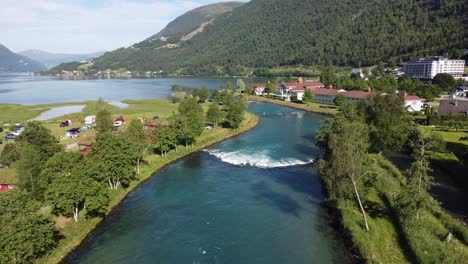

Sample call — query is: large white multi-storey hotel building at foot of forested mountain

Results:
[403,57,465,79]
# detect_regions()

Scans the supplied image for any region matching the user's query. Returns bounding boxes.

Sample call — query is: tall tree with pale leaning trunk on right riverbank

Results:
[319,116,373,230]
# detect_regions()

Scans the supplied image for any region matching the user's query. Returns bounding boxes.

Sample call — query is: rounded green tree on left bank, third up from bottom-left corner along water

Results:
[88,132,137,190]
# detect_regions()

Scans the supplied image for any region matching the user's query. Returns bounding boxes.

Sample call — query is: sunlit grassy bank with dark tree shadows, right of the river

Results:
[331,154,468,263]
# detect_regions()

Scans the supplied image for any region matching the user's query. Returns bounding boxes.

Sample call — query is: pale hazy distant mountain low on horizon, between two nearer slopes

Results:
[18,50,104,69]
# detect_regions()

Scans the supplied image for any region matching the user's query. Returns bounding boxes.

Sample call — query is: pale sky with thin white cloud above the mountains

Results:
[0,0,234,53]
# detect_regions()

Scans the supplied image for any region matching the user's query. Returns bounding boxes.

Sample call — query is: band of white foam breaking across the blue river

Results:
[204,149,314,168]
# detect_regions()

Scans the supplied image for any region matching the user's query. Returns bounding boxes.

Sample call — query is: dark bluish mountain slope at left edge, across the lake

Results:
[0,44,46,72]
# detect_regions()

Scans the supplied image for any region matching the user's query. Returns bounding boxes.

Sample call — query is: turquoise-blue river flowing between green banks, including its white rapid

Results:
[64,103,349,264]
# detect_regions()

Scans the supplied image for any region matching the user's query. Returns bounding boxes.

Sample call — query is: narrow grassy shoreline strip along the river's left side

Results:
[37,112,260,263]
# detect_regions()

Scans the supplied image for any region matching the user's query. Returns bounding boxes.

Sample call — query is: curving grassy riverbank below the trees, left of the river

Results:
[37,113,259,263]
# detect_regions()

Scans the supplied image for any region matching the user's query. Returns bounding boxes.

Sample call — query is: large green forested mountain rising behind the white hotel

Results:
[52,0,468,75]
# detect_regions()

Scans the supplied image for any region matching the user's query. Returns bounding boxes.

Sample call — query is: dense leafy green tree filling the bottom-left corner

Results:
[0,190,58,263]
